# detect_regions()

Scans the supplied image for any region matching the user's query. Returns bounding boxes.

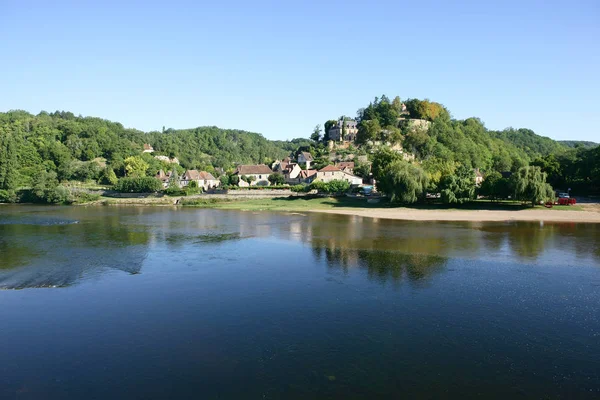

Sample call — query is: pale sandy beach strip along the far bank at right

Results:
[311,208,600,223]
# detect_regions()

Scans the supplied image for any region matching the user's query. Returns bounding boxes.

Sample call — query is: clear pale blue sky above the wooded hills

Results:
[0,0,600,141]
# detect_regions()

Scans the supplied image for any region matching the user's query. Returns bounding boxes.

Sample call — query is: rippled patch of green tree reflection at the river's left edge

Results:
[0,215,150,289]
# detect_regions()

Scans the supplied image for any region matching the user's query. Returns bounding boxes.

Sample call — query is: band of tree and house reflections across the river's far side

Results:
[0,206,600,288]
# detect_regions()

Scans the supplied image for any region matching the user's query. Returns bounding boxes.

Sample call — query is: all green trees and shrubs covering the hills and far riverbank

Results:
[0,96,600,207]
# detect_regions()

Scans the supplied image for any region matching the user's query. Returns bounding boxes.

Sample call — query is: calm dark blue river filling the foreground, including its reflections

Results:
[0,206,600,399]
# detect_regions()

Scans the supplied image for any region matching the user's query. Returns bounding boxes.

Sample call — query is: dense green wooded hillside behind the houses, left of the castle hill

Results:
[0,111,308,189]
